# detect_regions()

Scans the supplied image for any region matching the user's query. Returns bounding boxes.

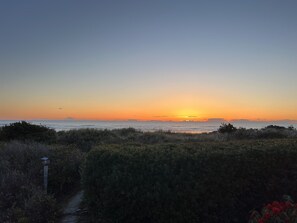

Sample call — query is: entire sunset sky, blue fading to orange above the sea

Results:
[0,0,297,121]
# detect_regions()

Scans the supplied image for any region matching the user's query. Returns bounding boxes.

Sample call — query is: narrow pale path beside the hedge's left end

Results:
[60,191,83,223]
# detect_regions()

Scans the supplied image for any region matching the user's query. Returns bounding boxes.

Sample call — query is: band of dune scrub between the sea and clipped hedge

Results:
[0,121,297,149]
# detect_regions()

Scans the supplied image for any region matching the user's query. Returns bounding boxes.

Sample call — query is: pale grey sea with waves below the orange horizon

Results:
[0,120,297,133]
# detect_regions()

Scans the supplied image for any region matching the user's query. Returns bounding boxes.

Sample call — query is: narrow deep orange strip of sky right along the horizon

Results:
[0,109,297,121]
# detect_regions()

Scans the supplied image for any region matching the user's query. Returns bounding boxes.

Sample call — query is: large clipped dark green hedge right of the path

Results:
[83,139,297,223]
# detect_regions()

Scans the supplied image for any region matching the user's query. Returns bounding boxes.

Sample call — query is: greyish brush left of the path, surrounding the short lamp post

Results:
[0,141,83,223]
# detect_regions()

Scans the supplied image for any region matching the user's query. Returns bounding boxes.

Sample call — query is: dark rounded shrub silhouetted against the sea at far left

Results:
[0,121,56,142]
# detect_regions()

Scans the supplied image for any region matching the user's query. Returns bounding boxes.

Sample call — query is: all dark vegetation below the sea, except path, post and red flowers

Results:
[0,122,297,223]
